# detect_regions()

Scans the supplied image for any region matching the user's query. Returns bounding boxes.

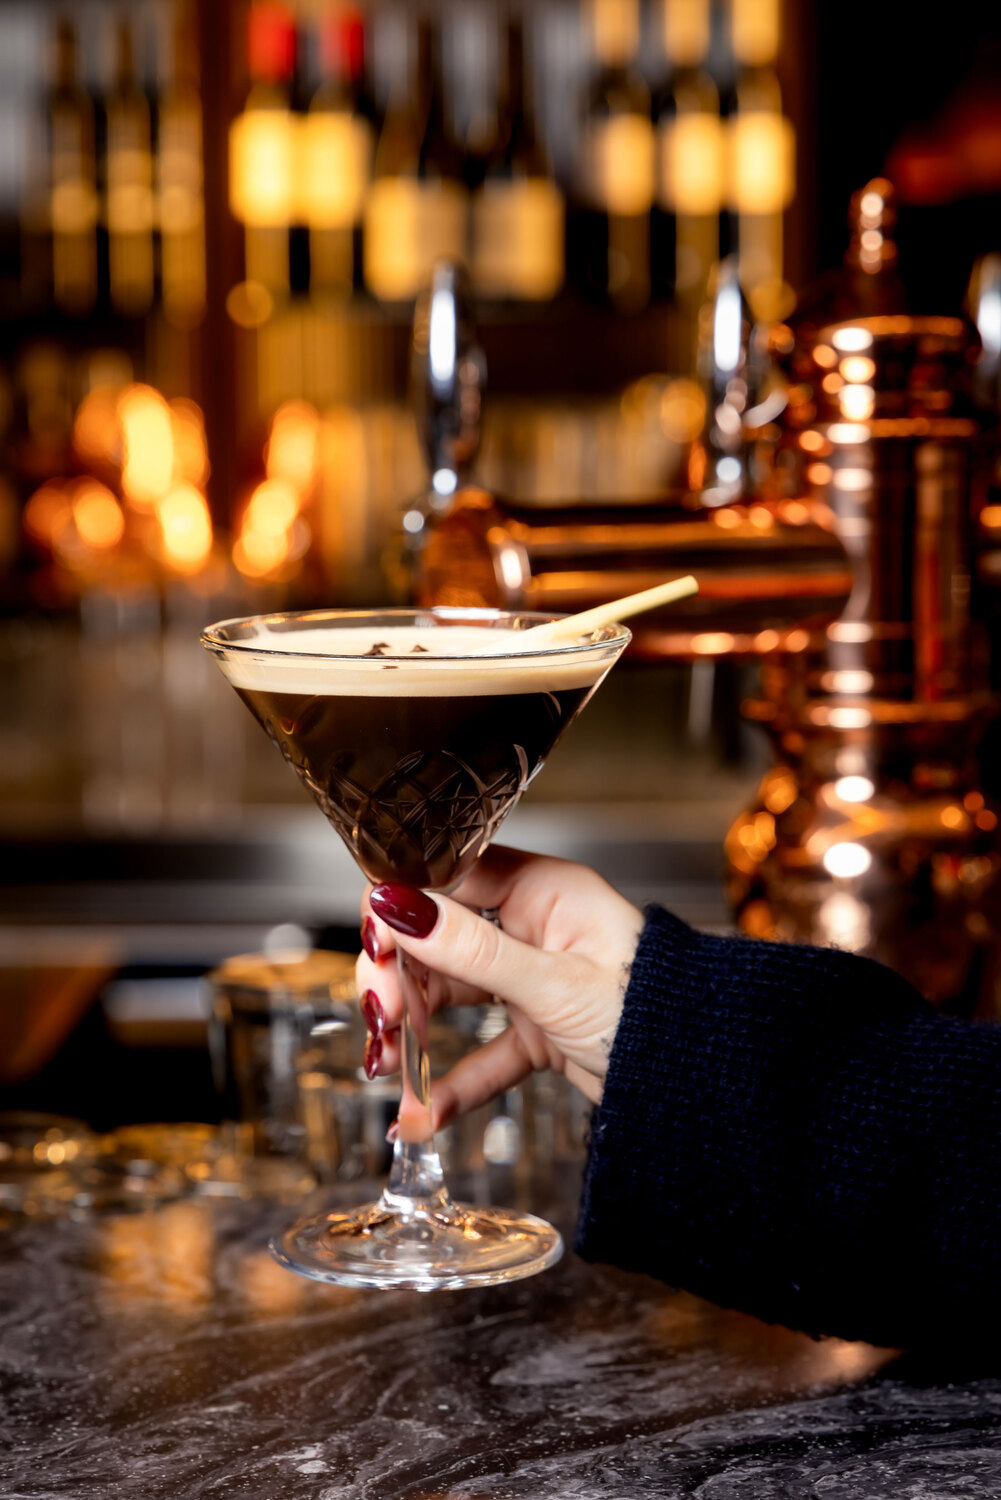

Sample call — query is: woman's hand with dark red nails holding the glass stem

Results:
[357,848,644,1128]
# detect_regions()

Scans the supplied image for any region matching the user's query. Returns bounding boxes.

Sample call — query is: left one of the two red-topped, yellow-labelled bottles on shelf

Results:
[230,0,296,296]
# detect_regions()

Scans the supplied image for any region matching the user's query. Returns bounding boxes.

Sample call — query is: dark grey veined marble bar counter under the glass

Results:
[0,1200,1001,1500]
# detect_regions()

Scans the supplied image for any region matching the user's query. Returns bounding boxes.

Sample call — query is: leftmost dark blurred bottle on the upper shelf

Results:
[48,20,98,314]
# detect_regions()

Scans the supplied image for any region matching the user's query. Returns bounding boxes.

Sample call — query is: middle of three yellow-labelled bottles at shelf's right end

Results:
[653,0,725,328]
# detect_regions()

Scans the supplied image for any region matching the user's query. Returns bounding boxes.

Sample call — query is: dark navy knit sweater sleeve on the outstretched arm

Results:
[576,909,1001,1347]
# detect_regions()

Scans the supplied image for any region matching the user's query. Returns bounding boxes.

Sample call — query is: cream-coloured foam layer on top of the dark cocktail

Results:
[219,626,618,698]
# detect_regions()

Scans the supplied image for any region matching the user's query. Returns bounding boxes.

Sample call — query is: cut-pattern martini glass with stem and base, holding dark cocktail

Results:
[201,609,629,1292]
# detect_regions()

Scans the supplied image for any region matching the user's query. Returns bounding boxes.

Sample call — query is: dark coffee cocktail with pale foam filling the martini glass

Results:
[217,624,618,891]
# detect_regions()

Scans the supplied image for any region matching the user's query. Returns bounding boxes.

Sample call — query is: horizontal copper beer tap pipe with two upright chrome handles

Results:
[404,263,849,659]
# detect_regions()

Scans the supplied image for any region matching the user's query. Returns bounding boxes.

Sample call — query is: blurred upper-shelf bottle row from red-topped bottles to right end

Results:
[230,0,795,378]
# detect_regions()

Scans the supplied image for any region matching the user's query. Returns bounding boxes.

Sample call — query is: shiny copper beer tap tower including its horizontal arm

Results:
[414,179,1001,1014]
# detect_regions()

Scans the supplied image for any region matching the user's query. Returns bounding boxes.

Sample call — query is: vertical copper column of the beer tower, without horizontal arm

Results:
[726,179,1001,1014]
